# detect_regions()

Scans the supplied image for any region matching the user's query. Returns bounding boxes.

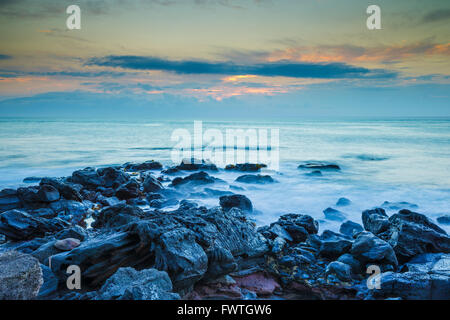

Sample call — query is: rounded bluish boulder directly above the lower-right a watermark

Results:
[350,231,398,268]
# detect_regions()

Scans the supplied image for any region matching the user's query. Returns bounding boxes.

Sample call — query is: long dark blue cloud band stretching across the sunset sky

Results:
[86,56,396,79]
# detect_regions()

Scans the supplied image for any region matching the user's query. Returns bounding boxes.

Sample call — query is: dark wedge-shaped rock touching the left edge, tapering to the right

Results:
[0,210,67,241]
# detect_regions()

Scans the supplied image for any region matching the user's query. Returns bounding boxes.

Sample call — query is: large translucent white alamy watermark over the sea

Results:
[171,121,280,170]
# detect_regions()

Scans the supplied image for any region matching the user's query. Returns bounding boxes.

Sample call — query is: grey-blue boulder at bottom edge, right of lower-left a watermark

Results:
[98,268,180,300]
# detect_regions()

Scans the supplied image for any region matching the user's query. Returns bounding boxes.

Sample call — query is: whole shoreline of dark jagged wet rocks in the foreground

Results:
[0,161,450,300]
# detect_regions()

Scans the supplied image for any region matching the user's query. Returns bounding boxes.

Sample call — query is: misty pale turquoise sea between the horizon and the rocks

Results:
[0,118,450,232]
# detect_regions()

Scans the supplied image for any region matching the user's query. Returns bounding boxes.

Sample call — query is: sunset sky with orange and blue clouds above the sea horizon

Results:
[0,0,450,119]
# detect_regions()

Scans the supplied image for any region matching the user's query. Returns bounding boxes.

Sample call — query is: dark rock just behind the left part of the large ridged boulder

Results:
[92,203,145,229]
